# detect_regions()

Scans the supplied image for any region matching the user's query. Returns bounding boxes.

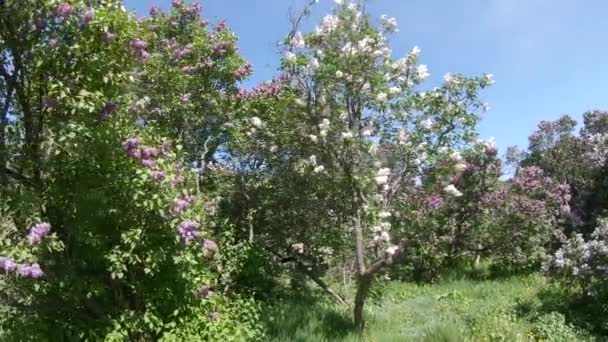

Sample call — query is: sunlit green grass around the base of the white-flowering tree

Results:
[266,275,593,342]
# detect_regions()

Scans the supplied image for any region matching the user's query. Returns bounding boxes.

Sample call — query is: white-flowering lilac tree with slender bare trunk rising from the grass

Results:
[227,1,493,328]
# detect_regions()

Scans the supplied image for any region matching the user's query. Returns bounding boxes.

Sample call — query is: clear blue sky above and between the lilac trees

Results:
[125,0,608,153]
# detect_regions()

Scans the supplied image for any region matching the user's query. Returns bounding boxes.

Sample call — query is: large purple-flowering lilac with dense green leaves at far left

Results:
[0,0,260,340]
